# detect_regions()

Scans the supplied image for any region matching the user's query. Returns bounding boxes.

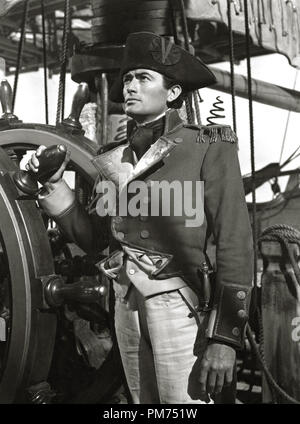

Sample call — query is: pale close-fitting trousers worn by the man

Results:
[115,285,212,404]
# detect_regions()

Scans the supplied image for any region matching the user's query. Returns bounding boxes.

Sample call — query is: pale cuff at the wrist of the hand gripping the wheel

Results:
[38,180,75,217]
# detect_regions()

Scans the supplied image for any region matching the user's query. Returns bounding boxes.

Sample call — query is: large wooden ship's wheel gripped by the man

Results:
[0,84,121,403]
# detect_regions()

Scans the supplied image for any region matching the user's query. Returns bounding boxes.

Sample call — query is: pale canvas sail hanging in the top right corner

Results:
[185,0,300,69]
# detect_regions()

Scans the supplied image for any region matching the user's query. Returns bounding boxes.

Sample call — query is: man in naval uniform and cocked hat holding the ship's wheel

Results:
[29,32,252,403]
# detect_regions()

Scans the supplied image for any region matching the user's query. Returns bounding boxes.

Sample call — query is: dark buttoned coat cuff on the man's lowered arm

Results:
[206,284,252,349]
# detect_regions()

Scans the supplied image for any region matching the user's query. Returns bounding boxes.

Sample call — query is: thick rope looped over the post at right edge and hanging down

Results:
[246,224,300,405]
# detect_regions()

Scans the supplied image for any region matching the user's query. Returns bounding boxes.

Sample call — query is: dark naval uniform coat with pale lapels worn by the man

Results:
[40,110,253,348]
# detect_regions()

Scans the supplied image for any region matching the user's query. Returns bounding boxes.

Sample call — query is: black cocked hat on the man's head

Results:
[109,32,216,103]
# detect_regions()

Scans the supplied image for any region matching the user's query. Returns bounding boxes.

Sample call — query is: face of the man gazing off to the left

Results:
[123,69,170,123]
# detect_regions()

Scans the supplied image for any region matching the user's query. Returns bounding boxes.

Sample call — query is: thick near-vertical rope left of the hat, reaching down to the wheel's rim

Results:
[56,0,70,125]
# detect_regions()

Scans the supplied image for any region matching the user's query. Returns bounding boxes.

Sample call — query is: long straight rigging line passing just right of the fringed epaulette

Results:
[244,0,258,302]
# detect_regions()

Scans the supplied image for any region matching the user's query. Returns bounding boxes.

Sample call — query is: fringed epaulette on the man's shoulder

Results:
[184,124,238,144]
